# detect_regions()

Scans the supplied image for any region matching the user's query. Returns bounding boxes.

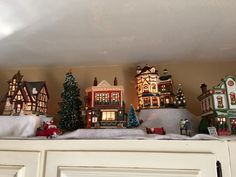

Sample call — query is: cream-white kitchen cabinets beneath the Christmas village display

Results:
[0,140,232,177]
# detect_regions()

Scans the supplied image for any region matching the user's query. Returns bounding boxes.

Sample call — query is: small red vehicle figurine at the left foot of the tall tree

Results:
[36,121,62,138]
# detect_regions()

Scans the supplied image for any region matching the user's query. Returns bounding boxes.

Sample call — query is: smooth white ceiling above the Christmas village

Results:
[0,0,236,67]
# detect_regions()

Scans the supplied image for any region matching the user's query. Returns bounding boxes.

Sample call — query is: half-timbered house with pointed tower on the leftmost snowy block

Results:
[2,71,49,115]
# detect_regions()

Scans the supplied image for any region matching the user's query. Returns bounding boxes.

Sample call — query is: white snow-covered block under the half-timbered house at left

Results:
[0,115,41,137]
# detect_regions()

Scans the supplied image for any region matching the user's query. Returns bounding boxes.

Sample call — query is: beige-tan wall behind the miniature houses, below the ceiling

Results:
[0,62,236,117]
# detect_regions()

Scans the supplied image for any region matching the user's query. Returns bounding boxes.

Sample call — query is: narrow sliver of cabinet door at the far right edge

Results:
[229,141,236,177]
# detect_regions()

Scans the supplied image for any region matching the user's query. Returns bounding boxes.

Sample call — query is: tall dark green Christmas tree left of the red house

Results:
[58,72,83,131]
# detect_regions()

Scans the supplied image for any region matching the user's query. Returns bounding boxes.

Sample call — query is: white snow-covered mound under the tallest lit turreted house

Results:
[139,108,200,135]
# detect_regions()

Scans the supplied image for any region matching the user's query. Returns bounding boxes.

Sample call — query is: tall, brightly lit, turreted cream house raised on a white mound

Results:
[136,65,175,109]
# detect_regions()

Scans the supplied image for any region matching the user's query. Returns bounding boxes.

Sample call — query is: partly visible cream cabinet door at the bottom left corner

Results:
[0,151,39,177]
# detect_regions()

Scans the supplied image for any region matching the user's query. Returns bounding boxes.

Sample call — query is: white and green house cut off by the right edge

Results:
[198,76,236,135]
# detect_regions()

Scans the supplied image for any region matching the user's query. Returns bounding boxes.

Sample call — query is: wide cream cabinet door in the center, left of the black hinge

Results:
[45,151,217,177]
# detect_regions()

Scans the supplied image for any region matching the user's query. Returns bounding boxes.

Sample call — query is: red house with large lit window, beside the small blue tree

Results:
[85,78,126,128]
